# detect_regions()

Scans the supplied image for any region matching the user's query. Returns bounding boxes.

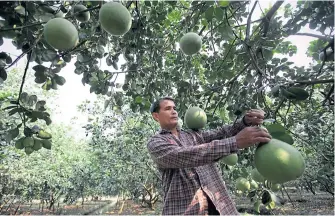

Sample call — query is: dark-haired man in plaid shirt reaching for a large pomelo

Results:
[147,97,271,215]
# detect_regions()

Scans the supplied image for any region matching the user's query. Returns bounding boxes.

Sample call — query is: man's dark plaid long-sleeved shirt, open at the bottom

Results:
[147,121,246,215]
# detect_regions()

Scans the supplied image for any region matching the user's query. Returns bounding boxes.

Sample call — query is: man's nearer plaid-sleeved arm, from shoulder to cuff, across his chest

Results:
[147,137,238,169]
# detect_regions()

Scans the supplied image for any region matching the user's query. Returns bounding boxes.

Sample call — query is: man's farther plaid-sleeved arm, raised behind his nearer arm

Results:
[201,117,248,142]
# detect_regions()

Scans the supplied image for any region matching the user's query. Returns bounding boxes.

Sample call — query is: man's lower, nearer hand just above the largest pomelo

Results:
[235,127,272,149]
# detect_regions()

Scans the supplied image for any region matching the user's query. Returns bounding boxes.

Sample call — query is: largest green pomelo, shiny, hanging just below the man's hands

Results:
[255,139,305,183]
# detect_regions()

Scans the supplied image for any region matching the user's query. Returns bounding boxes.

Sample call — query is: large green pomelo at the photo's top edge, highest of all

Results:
[99,2,132,36]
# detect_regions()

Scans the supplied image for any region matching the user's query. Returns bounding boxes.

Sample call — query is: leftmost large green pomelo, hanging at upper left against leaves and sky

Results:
[44,18,79,51]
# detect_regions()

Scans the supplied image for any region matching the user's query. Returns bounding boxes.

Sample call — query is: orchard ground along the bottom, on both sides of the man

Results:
[0,190,334,215]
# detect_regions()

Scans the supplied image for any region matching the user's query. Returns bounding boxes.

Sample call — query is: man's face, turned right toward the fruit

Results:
[153,100,178,128]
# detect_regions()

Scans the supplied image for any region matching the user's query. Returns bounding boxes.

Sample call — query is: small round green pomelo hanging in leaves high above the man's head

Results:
[179,32,202,55]
